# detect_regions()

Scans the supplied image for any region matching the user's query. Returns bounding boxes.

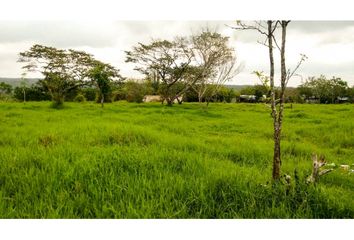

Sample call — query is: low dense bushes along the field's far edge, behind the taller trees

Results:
[0,75,354,104]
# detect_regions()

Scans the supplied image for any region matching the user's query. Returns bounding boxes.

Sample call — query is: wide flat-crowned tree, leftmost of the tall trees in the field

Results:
[19,44,94,106]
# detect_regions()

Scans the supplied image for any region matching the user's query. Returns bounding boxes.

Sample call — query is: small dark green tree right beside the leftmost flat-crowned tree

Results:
[88,61,122,108]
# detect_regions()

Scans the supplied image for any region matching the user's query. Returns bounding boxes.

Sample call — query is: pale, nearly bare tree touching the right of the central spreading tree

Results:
[191,29,238,106]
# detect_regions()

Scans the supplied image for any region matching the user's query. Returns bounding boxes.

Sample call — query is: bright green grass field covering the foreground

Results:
[0,102,354,218]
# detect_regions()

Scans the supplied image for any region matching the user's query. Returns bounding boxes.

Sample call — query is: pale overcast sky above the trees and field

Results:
[0,20,354,86]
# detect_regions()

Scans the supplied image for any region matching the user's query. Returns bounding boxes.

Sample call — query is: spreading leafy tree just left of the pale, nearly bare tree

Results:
[126,38,193,106]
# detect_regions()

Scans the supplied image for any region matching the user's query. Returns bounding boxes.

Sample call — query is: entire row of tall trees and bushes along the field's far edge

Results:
[0,29,353,107]
